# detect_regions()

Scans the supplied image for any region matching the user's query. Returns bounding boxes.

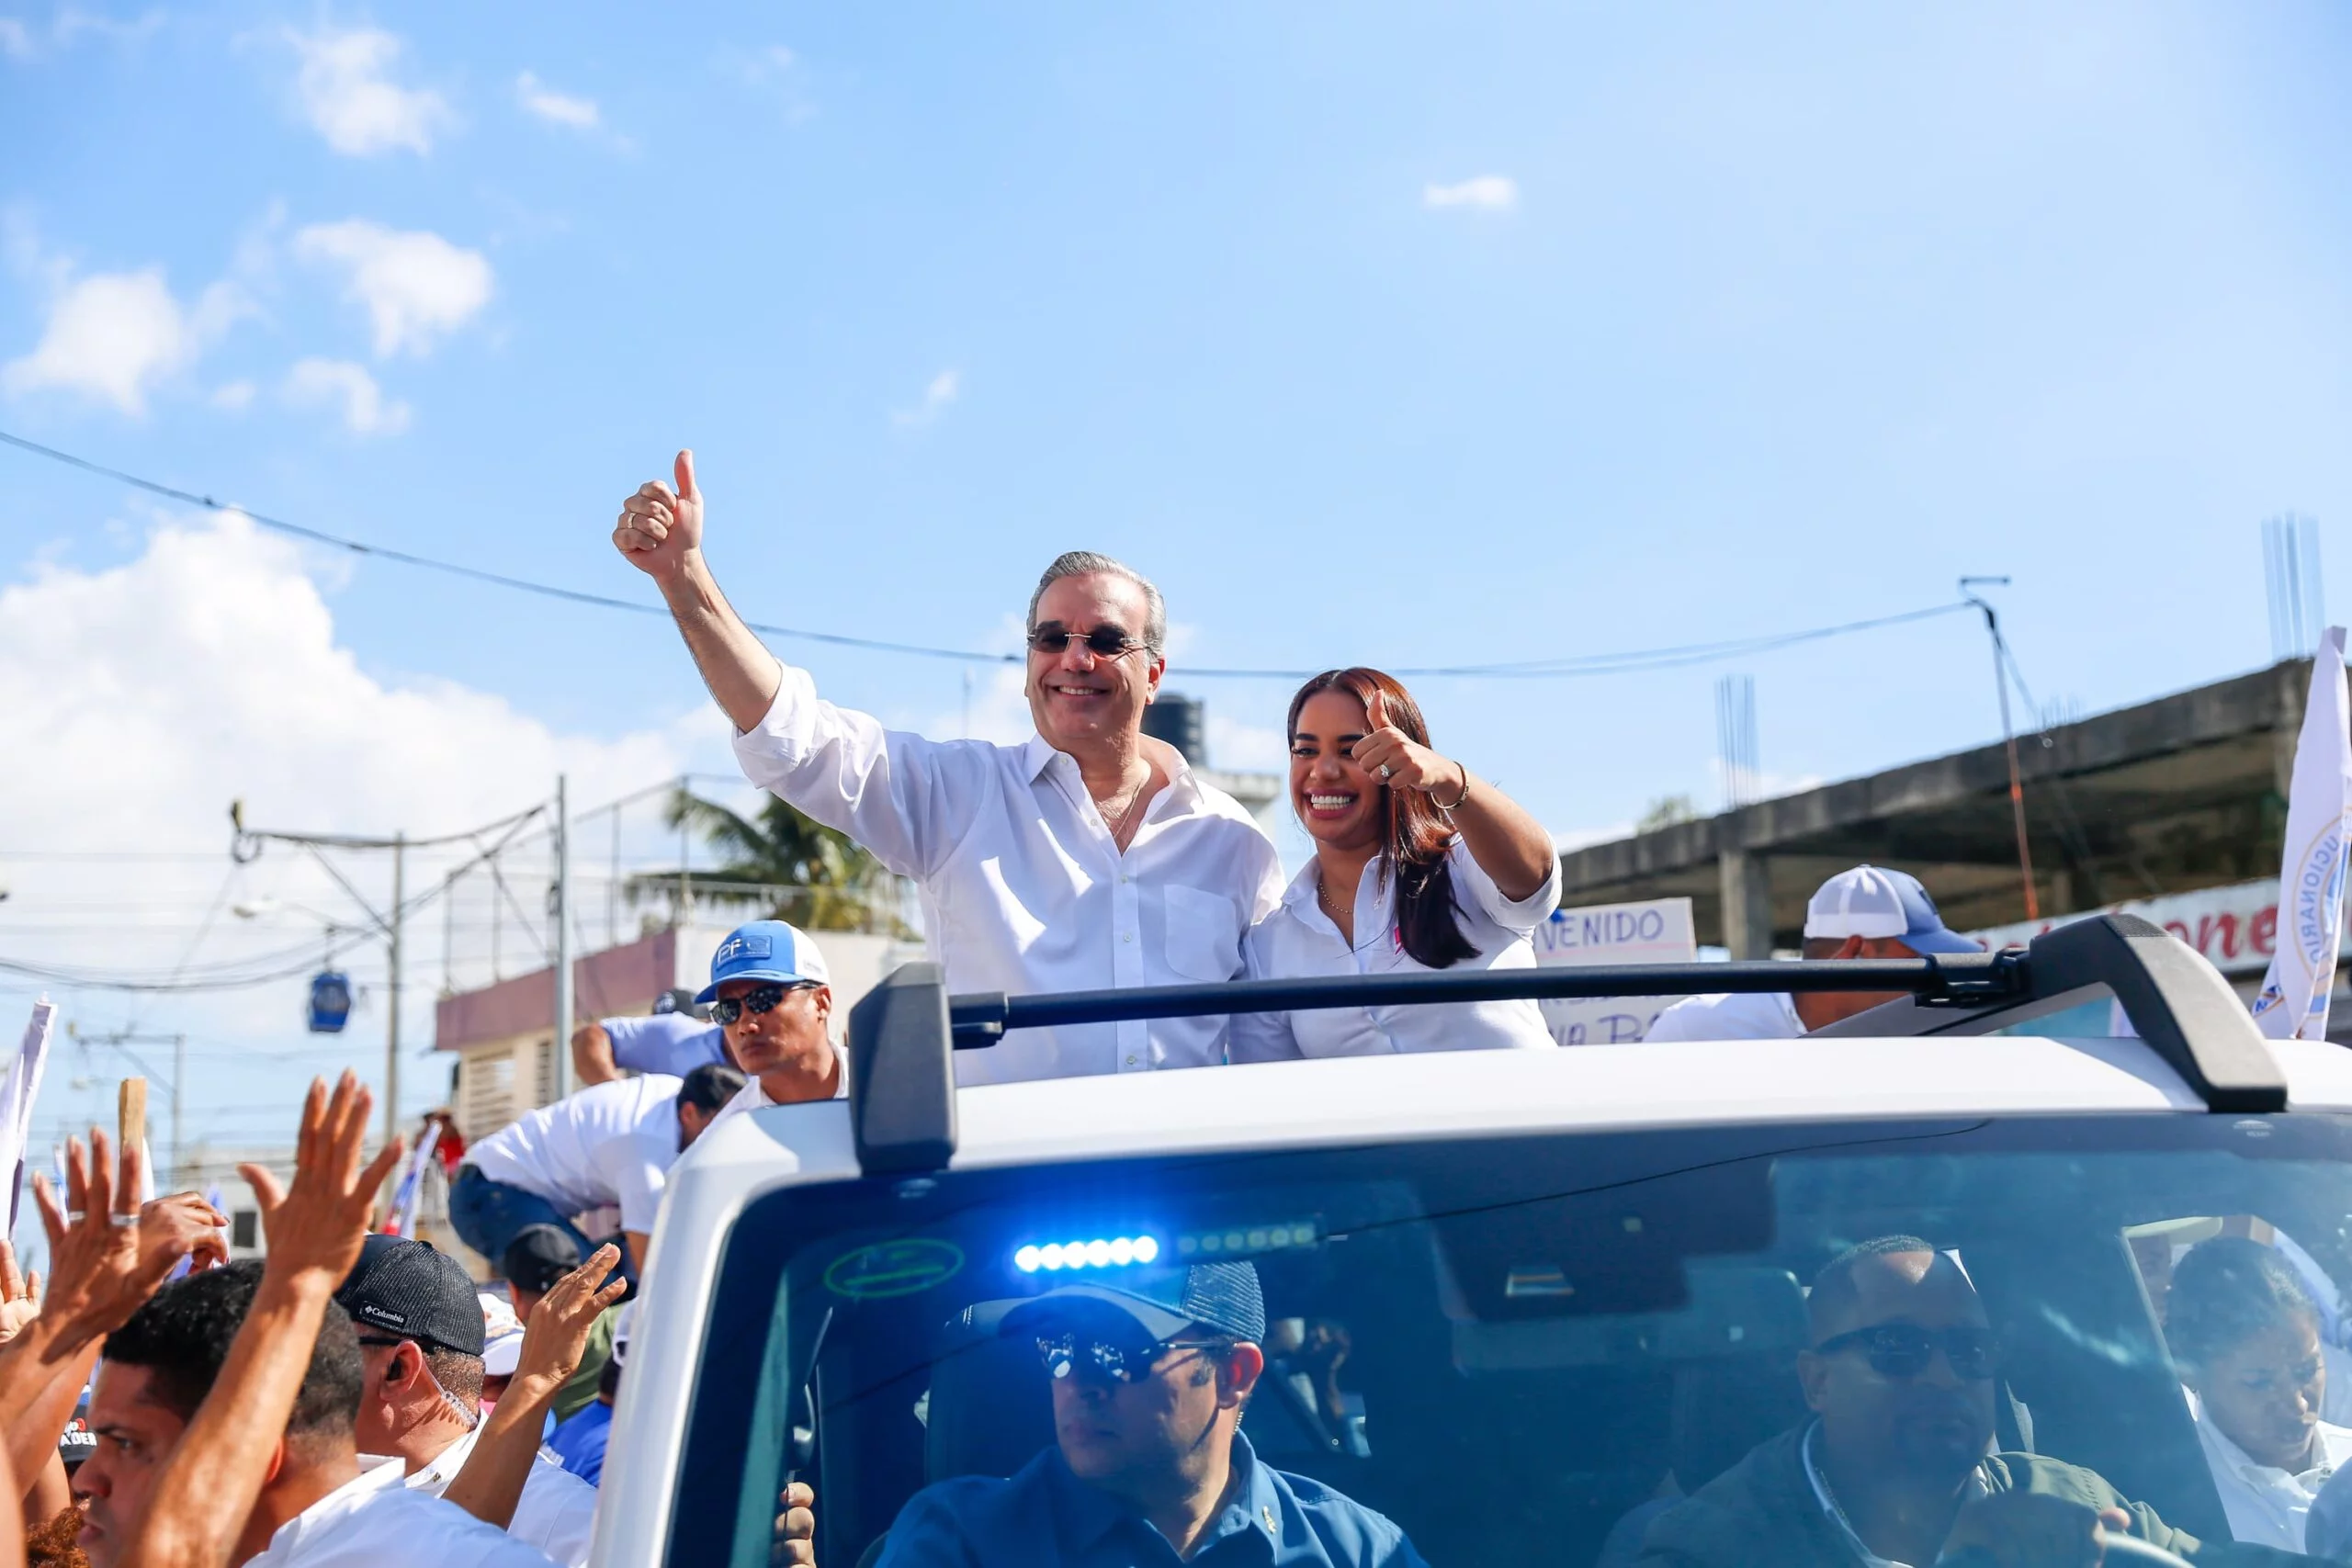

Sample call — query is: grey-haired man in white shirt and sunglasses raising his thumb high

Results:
[614,451,1282,1084]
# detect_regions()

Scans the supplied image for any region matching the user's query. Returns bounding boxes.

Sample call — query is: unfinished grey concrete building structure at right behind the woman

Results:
[1559,660,2310,959]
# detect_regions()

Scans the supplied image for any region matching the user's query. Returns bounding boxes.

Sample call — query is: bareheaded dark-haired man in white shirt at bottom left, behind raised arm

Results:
[75,1262,548,1568]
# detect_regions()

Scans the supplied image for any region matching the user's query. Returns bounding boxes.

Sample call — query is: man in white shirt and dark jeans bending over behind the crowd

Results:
[449,1065,743,1279]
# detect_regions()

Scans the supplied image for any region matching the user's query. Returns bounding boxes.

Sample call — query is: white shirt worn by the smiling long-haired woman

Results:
[1232,837,1559,1063]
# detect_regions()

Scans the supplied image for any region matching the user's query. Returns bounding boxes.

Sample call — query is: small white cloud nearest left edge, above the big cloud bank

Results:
[0,265,252,416]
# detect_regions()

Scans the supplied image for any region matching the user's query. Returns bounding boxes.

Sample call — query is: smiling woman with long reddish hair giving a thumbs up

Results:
[1230,670,1559,1063]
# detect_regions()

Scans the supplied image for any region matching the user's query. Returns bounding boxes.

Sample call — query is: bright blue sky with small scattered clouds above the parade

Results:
[0,0,2352,1189]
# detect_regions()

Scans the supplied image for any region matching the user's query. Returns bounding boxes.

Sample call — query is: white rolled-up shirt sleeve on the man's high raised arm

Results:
[734,665,992,877]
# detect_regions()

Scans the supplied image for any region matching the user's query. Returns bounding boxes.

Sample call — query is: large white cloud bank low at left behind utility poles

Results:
[0,514,724,1152]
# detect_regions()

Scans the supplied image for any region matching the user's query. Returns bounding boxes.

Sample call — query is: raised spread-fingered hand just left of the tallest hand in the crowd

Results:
[33,1128,228,1361]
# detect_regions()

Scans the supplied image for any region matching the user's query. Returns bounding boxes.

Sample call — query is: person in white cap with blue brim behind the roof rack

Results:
[1644,865,1983,1043]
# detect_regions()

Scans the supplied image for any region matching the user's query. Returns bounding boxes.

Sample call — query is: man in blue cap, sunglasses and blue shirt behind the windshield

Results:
[877,1262,1425,1568]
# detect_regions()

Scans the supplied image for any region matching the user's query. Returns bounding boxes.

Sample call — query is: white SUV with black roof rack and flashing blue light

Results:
[595,917,2352,1568]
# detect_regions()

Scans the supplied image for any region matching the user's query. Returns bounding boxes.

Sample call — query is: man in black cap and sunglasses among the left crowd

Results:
[334,1236,595,1568]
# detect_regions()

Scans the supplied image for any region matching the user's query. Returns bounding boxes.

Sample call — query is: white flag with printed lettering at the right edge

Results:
[2253,626,2352,1039]
